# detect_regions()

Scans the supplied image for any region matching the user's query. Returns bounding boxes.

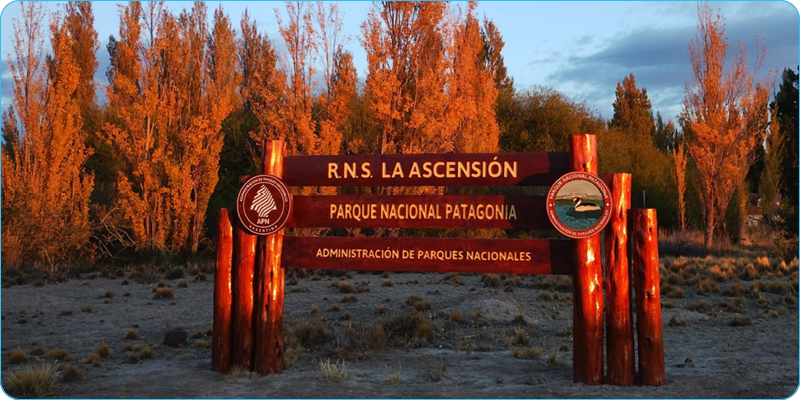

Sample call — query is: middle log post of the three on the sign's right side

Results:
[605,173,636,386]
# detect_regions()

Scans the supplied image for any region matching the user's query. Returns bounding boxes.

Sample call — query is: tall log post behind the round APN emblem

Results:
[254,140,286,374]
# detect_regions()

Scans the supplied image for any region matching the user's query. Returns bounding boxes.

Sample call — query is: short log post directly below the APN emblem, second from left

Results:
[232,205,256,369]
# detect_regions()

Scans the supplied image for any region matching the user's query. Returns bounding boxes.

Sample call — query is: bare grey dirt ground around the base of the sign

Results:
[1,259,798,398]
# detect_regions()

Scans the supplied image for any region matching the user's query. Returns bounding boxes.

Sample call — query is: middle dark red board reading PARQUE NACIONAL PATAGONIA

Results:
[288,195,552,229]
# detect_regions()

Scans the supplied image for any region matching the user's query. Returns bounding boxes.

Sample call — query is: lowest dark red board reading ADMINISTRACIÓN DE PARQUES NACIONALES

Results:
[282,236,574,275]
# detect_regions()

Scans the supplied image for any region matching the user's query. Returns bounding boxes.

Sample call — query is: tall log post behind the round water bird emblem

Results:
[570,135,603,385]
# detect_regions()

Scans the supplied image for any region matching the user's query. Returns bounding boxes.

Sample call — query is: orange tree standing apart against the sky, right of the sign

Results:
[681,3,772,247]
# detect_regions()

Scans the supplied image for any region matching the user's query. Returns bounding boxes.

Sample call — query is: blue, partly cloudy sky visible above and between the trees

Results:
[0,0,800,119]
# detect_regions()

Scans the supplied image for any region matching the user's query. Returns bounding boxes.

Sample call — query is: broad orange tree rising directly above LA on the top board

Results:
[361,1,455,154]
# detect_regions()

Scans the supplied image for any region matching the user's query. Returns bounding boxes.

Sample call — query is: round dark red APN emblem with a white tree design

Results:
[236,175,292,235]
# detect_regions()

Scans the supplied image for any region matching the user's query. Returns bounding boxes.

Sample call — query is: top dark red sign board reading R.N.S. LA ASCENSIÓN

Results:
[284,153,570,186]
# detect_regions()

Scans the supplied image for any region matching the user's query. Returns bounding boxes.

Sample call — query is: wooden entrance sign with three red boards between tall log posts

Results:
[213,135,664,384]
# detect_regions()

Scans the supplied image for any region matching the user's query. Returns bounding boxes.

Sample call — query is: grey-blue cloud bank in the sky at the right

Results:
[543,8,798,118]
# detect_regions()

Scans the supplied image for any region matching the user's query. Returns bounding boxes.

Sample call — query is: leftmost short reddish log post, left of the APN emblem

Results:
[211,208,233,372]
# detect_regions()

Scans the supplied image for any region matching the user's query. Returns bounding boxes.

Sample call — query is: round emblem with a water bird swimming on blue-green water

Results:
[547,172,611,239]
